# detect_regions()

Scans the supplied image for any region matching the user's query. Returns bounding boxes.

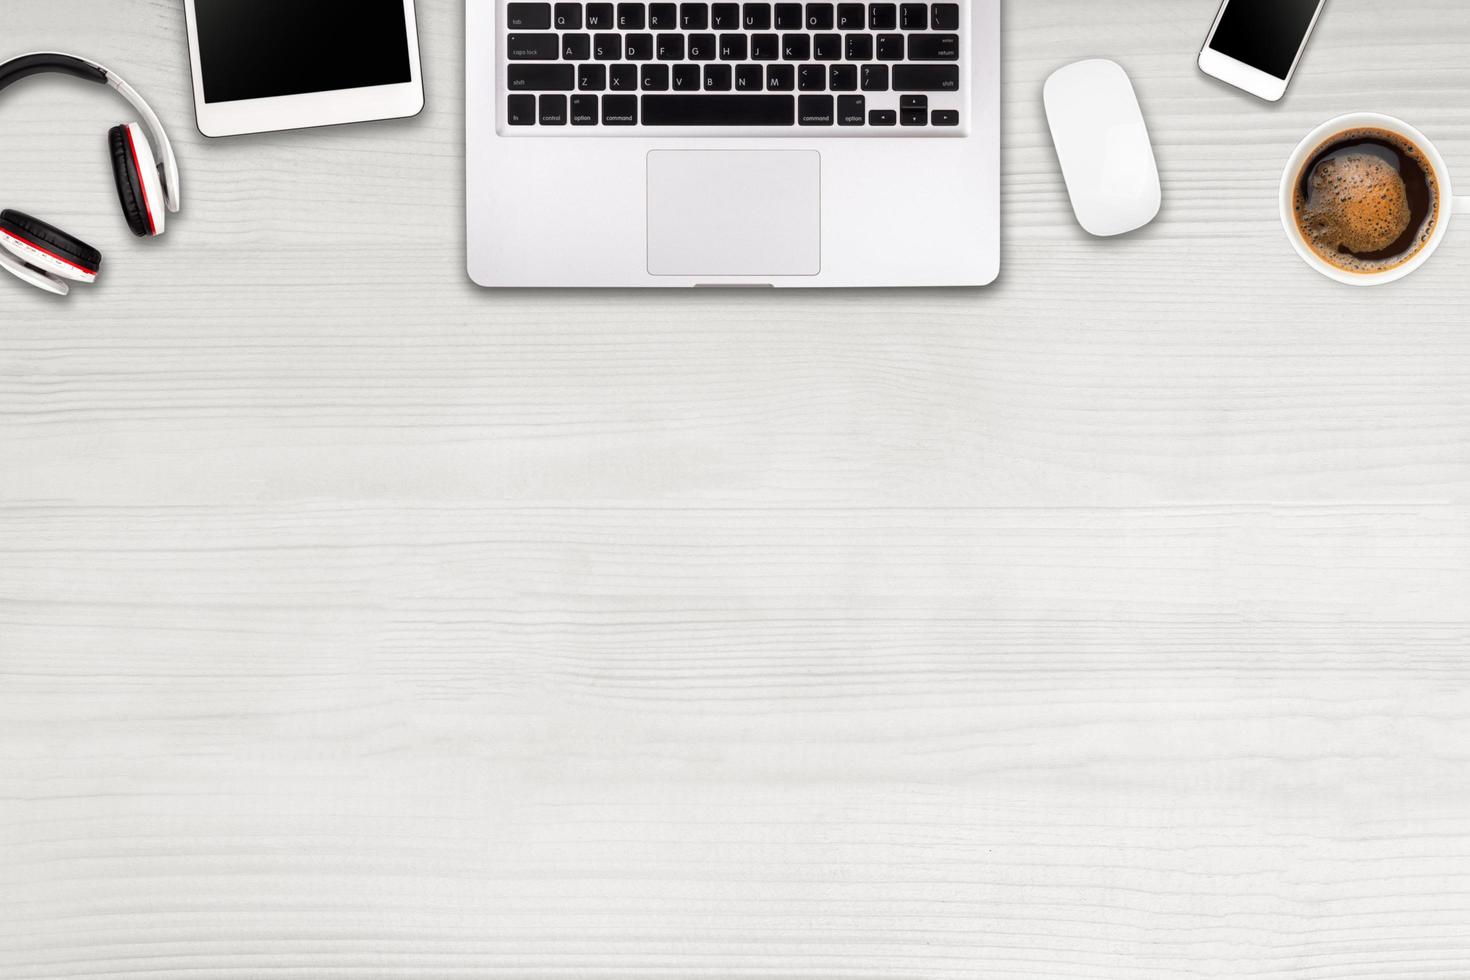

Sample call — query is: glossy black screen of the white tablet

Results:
[194,0,413,103]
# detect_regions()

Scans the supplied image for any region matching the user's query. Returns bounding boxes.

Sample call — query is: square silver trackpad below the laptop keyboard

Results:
[648,150,822,276]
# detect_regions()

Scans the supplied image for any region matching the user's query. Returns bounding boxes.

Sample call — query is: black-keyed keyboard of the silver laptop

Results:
[500,0,966,137]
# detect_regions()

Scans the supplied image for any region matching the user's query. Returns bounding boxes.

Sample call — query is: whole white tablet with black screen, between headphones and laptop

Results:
[184,0,423,137]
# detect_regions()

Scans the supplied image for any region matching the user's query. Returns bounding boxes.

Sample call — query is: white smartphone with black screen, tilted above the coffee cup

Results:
[1200,0,1326,101]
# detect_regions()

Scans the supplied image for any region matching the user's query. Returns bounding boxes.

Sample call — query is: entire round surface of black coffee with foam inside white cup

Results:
[1295,129,1439,275]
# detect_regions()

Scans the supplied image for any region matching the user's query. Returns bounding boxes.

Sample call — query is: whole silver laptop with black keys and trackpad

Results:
[466,0,1001,288]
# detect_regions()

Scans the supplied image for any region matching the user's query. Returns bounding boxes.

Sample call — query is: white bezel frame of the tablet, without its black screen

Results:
[184,0,423,138]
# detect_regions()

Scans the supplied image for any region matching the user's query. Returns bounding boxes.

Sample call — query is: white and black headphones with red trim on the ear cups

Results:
[0,51,181,295]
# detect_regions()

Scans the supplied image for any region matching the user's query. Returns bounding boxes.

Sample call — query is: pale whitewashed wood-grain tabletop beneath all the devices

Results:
[0,0,1470,980]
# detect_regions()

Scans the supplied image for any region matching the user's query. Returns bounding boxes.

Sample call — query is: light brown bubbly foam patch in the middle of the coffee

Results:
[1302,153,1411,254]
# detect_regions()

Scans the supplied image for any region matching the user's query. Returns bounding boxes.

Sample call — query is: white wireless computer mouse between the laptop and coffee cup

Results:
[1044,59,1163,237]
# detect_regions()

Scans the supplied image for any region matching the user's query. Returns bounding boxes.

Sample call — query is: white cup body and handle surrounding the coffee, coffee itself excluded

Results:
[1280,112,1470,287]
